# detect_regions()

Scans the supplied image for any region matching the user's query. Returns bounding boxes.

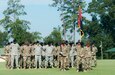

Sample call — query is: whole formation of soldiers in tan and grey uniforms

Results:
[4,41,97,72]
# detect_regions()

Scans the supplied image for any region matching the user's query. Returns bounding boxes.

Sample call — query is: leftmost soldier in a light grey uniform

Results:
[10,40,19,69]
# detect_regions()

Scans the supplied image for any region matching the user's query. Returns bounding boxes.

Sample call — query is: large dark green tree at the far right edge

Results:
[84,0,115,58]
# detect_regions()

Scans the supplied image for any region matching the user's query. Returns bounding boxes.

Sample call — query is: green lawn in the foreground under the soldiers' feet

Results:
[0,60,115,75]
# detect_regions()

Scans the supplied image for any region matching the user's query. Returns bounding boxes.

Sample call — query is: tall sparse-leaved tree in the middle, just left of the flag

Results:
[52,0,85,42]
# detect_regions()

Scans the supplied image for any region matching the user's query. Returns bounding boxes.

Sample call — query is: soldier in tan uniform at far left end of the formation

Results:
[4,43,11,68]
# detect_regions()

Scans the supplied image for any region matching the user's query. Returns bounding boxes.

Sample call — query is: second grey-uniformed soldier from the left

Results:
[34,42,42,69]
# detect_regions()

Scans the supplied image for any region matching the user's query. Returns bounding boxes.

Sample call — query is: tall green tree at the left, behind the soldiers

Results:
[0,0,40,43]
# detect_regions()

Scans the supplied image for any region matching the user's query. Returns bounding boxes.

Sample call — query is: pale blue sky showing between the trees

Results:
[0,0,91,40]
